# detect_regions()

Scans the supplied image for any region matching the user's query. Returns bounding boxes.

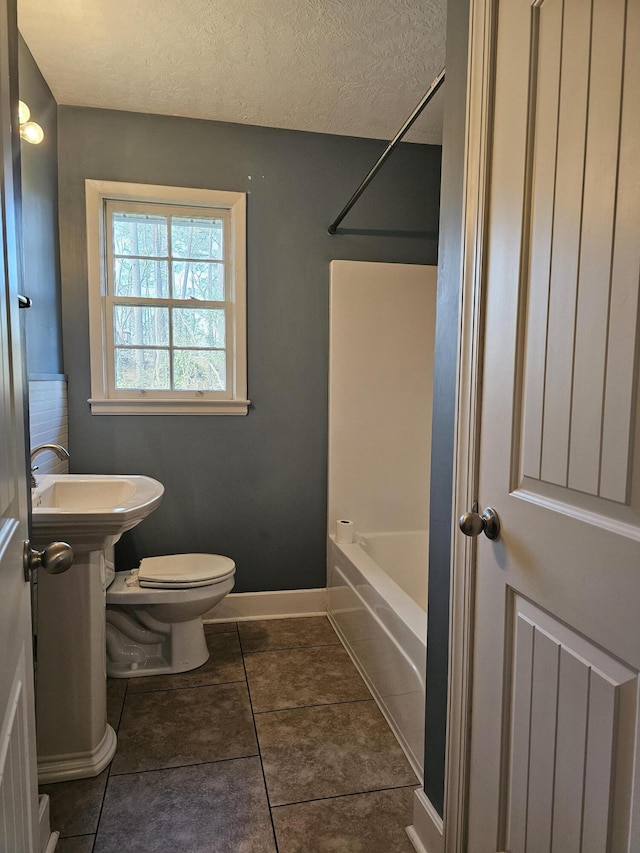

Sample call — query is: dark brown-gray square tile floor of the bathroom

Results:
[42,617,417,853]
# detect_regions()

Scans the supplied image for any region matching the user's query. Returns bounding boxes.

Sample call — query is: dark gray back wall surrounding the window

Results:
[58,107,440,592]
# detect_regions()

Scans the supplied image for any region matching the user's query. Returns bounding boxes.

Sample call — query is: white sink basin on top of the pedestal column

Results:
[31,474,164,550]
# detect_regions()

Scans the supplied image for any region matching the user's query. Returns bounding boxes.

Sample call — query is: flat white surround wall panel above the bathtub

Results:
[328,261,436,532]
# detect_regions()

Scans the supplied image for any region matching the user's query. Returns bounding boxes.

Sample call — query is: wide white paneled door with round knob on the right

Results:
[460,0,640,853]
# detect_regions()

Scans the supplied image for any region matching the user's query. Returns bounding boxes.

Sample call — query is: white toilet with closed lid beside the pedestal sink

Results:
[106,554,236,678]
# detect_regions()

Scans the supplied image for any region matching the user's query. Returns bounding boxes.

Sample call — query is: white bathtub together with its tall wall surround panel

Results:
[327,261,436,776]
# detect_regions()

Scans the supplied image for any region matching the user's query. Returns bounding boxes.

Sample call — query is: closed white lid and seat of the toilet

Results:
[138,554,236,589]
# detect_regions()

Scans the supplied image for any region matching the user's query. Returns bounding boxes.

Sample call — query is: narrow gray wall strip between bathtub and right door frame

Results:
[424,0,469,815]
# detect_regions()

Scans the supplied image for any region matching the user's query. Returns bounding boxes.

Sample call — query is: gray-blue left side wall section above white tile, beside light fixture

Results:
[18,37,62,374]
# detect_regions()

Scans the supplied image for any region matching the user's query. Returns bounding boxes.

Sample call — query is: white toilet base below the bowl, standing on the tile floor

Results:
[107,607,209,678]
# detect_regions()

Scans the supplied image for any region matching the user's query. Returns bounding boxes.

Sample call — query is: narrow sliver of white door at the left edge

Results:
[0,0,38,853]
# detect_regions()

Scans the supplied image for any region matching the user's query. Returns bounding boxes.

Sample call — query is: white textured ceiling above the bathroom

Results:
[18,0,446,143]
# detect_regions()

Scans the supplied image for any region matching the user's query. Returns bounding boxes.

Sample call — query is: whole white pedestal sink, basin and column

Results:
[32,474,164,783]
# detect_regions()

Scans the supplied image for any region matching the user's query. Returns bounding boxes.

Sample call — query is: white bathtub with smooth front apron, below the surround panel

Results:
[327,531,428,779]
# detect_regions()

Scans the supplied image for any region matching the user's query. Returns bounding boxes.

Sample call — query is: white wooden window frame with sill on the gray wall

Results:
[85,180,250,415]
